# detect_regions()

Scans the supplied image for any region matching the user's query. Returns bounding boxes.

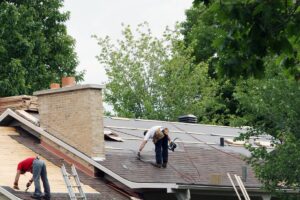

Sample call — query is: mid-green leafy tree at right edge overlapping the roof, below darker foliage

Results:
[235,63,300,195]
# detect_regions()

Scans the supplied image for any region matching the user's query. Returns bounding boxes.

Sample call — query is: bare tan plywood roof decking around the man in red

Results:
[0,127,97,193]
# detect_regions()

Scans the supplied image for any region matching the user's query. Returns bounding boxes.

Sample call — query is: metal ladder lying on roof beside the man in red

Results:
[61,164,86,200]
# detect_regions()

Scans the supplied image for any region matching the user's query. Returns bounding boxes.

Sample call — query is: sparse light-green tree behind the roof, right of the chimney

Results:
[96,23,217,120]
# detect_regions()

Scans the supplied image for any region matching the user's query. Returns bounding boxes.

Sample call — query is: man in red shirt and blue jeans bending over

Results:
[13,156,50,199]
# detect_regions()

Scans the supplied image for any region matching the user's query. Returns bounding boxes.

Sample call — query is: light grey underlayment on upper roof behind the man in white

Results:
[104,117,255,156]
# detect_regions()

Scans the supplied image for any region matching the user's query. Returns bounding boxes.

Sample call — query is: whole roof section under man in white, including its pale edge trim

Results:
[0,110,274,197]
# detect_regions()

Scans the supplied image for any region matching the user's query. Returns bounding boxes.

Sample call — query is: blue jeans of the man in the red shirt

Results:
[32,159,50,198]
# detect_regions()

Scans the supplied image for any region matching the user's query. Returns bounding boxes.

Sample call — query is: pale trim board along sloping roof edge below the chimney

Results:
[0,109,177,189]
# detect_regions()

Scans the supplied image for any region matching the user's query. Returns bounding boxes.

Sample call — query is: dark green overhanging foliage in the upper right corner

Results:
[183,0,300,78]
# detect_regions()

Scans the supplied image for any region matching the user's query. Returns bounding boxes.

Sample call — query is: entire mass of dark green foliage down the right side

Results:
[182,0,300,199]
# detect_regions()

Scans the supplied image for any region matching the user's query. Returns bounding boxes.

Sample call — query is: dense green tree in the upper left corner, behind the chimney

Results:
[0,0,83,96]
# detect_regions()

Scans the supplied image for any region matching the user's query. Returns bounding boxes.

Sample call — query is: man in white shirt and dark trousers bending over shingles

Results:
[138,126,171,168]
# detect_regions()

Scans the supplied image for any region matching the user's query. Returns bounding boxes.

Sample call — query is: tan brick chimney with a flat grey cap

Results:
[34,85,105,159]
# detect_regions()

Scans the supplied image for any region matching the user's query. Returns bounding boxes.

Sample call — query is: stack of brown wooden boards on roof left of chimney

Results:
[0,95,38,114]
